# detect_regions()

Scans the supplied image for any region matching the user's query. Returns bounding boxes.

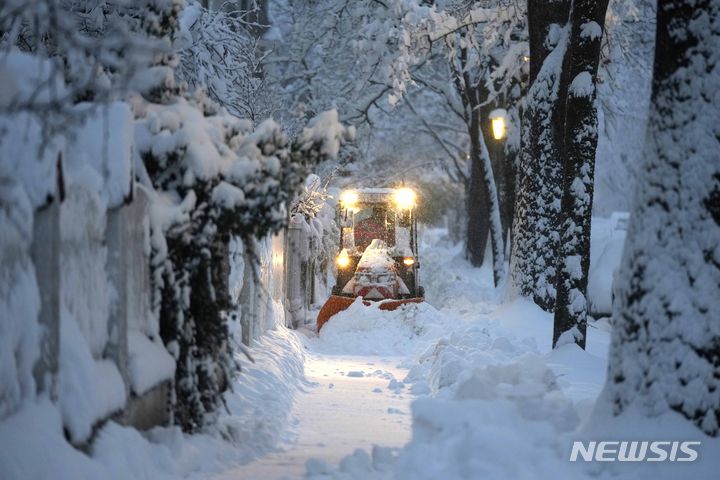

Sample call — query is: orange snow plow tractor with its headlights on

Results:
[317,187,425,332]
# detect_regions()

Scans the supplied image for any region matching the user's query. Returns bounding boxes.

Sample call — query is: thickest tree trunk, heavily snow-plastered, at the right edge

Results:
[604,0,720,436]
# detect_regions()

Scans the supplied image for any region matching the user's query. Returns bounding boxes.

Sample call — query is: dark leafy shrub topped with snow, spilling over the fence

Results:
[132,4,353,431]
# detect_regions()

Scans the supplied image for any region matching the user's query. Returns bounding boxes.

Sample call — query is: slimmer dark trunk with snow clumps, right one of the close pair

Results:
[553,0,608,348]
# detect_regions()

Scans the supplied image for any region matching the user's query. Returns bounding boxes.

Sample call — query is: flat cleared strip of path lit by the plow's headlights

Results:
[215,338,411,479]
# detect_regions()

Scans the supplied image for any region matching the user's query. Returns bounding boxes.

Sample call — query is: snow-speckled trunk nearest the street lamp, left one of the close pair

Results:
[511,0,570,311]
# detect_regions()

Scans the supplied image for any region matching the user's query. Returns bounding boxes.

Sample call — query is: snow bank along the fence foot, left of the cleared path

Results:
[0,322,305,480]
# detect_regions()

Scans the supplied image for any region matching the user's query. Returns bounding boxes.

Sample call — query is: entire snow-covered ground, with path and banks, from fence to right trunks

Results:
[0,230,720,480]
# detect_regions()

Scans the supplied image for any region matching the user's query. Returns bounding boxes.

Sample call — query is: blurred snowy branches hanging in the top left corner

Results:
[0,0,169,129]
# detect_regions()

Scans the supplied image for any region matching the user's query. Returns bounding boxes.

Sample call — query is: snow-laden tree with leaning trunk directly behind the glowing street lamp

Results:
[340,1,527,283]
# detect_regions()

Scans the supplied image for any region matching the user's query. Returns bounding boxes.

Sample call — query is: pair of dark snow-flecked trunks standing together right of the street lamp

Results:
[511,0,608,345]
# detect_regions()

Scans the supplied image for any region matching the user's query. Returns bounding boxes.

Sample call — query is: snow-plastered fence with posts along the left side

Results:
[0,53,175,444]
